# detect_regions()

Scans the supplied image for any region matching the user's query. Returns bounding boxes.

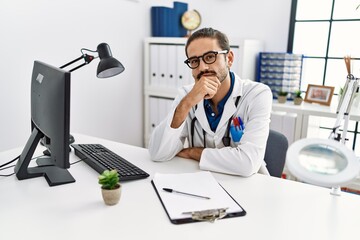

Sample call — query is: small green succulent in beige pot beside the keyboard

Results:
[99,170,121,206]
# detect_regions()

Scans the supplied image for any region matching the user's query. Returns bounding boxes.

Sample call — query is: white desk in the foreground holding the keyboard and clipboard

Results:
[0,134,360,240]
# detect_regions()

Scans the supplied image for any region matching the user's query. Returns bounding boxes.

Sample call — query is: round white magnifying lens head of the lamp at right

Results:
[286,138,360,195]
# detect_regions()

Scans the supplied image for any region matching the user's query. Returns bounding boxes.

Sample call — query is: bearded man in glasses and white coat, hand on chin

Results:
[149,28,272,176]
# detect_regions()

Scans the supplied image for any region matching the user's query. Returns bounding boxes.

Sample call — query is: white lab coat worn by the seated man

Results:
[149,75,272,177]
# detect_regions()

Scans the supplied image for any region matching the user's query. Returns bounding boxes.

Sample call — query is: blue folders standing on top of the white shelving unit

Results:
[151,2,188,37]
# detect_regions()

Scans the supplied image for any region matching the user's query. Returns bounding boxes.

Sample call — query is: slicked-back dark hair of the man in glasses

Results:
[185,28,230,57]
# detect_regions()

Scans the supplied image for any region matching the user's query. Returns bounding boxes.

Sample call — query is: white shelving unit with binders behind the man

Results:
[144,37,264,147]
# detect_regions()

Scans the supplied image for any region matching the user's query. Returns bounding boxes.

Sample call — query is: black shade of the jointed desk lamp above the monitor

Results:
[96,43,125,78]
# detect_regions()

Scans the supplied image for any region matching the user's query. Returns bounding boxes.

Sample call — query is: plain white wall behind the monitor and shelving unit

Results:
[0,0,291,151]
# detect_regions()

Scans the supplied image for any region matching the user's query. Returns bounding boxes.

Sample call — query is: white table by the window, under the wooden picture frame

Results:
[272,98,360,140]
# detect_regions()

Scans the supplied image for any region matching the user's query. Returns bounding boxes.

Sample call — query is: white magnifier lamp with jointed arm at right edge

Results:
[286,57,360,196]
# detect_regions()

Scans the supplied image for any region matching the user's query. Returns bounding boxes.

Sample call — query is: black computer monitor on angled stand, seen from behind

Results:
[15,61,75,186]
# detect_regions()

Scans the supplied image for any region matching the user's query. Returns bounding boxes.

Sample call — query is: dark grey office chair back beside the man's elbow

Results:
[264,129,289,177]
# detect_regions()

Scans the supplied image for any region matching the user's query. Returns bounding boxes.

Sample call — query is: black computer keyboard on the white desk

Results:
[71,144,149,181]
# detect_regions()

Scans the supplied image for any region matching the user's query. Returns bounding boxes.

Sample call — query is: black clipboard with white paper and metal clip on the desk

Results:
[151,171,246,224]
